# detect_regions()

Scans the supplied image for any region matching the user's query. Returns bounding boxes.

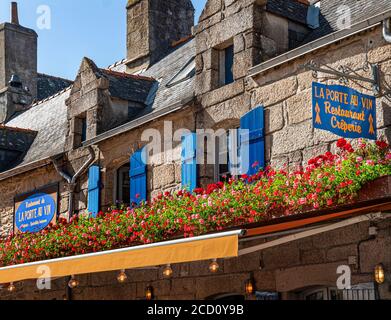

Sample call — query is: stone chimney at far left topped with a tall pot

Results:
[0,2,38,123]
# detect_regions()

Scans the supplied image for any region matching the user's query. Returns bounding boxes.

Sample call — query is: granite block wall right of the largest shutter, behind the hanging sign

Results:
[247,27,391,168]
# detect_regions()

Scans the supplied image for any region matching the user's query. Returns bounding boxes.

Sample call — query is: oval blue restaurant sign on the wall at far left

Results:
[15,193,57,233]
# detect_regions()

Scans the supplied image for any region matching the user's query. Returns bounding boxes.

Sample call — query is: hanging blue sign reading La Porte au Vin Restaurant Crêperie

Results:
[312,82,377,140]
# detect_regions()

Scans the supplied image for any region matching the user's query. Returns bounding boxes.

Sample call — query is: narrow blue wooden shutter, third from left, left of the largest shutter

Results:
[182,133,198,191]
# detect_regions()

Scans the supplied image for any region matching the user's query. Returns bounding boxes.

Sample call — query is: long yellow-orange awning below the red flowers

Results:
[0,229,246,283]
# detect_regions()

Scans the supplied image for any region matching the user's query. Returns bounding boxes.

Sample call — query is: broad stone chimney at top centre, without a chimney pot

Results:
[126,0,194,72]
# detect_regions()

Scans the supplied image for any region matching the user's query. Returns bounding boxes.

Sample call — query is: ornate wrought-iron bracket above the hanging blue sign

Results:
[304,61,380,95]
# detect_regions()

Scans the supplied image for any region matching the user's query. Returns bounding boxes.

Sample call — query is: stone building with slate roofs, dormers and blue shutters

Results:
[0,0,391,299]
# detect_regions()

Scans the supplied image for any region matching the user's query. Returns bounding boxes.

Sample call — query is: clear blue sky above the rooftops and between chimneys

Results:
[0,0,206,80]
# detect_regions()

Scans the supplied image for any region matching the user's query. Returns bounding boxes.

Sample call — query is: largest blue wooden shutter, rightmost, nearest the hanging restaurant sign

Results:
[240,107,265,175]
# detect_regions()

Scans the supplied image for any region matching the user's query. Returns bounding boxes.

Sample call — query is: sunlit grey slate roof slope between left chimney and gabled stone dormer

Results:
[6,89,70,165]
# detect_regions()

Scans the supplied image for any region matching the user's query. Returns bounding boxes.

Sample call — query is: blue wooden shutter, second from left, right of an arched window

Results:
[129,148,147,205]
